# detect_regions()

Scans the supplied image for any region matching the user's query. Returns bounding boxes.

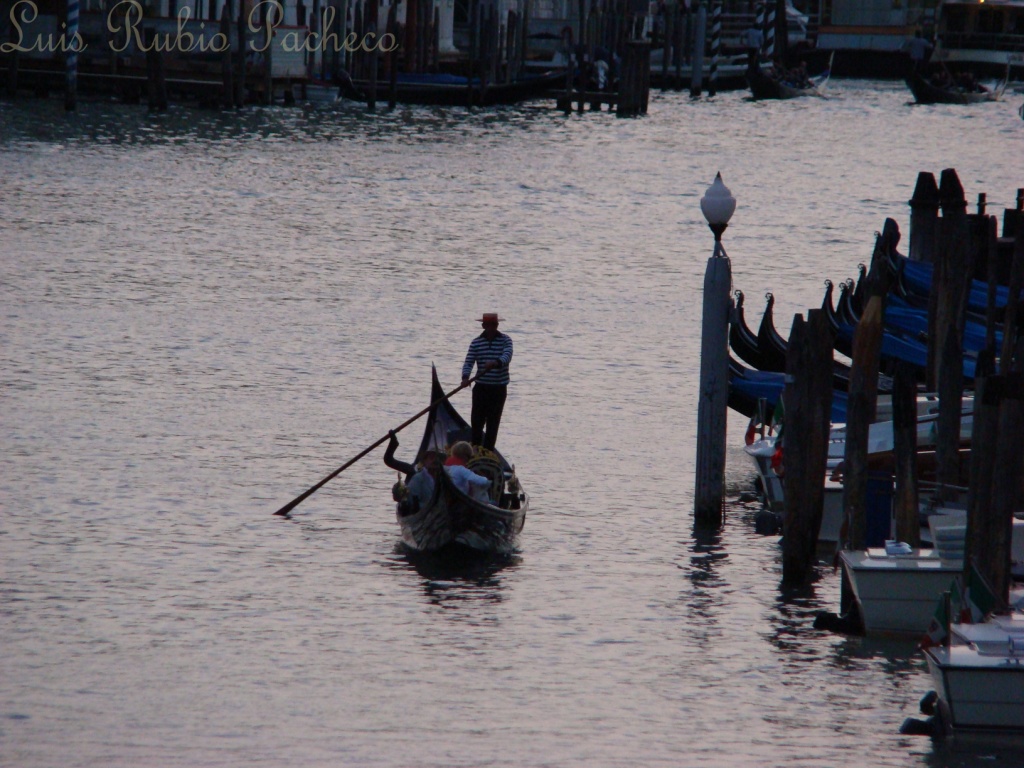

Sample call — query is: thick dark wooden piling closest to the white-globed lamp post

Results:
[782,309,833,584]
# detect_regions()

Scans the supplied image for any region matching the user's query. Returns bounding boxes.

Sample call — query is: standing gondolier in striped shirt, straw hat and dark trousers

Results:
[462,312,512,451]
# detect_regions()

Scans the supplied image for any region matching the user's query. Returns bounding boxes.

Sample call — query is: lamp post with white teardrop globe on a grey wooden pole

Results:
[694,173,736,526]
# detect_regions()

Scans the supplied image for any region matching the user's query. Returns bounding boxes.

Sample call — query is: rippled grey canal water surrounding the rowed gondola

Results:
[0,81,1024,768]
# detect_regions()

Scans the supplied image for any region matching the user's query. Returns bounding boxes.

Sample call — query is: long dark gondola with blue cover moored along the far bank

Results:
[340,71,565,106]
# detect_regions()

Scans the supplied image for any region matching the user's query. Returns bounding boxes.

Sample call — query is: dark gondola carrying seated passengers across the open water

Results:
[385,370,529,554]
